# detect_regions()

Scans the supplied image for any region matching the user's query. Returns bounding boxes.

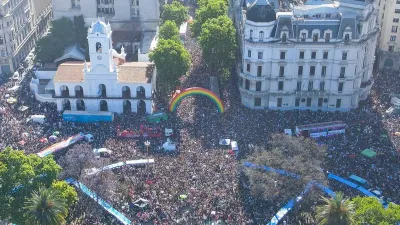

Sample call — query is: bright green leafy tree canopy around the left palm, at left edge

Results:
[0,148,77,224]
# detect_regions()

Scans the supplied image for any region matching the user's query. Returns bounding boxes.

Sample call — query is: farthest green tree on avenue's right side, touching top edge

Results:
[191,0,228,37]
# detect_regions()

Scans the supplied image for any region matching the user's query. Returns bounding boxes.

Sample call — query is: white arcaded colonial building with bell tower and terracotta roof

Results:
[31,21,156,113]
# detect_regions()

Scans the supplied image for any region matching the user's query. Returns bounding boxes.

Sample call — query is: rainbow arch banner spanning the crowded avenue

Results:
[169,87,225,113]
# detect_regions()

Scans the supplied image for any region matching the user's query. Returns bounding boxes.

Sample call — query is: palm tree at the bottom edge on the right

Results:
[316,192,354,225]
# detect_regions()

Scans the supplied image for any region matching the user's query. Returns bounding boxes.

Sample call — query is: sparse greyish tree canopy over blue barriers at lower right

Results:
[244,134,326,201]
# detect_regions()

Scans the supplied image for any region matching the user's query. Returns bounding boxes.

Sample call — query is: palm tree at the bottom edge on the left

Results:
[24,188,68,225]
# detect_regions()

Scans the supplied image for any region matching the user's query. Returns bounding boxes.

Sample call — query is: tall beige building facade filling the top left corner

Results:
[0,0,52,73]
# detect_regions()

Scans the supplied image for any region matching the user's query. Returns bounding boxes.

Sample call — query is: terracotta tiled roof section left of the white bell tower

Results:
[54,62,85,82]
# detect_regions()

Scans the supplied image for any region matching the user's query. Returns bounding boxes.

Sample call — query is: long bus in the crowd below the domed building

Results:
[296,121,346,138]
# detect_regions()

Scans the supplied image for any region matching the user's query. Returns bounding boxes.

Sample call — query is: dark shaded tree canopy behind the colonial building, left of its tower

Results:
[35,15,87,62]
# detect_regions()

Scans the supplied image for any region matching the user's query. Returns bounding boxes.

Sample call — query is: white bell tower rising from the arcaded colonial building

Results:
[87,20,115,73]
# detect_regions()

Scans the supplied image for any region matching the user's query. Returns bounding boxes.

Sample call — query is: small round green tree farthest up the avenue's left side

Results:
[162,0,189,27]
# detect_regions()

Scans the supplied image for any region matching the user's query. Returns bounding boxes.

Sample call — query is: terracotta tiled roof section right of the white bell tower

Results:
[118,62,154,83]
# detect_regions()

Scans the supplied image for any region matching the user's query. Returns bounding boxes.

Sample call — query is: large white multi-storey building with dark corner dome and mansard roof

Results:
[236,0,379,111]
